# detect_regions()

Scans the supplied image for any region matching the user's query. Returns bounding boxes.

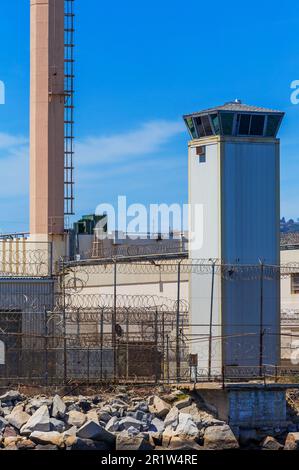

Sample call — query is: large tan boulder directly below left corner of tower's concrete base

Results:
[204,425,239,450]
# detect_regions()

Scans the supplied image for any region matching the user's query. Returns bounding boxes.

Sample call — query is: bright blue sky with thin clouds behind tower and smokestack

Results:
[0,0,299,231]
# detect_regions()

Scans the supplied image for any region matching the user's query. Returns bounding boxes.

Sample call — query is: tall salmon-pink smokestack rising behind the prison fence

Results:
[30,0,64,240]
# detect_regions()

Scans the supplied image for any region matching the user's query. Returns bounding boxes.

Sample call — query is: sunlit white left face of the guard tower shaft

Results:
[188,139,222,373]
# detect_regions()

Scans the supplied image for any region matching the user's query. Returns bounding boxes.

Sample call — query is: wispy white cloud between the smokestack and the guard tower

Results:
[76,120,185,166]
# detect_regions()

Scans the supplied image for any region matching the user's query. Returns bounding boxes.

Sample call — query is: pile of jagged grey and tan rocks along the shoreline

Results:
[0,387,299,451]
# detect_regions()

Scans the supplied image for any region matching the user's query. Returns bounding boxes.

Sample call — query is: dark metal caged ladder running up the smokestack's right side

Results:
[64,0,75,216]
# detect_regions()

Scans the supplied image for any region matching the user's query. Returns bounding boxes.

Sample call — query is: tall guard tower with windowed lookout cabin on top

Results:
[184,100,284,374]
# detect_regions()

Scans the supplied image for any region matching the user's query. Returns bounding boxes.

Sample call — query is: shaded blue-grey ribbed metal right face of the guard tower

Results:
[222,142,280,365]
